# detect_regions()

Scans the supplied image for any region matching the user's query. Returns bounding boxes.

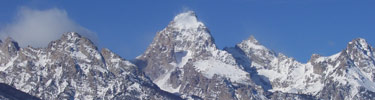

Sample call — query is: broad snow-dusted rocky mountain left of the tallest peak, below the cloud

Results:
[0,32,179,100]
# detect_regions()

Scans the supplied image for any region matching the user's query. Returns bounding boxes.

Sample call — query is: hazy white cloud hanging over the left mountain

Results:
[0,8,97,47]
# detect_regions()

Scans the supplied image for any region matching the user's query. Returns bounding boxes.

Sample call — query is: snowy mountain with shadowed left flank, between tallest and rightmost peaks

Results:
[226,36,322,94]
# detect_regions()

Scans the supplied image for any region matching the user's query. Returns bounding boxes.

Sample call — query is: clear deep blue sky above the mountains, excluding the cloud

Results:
[0,0,375,62]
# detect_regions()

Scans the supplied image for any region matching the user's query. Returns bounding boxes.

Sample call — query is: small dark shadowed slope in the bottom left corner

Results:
[0,83,40,100]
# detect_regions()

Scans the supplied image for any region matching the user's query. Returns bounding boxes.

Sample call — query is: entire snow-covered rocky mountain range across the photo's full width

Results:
[0,11,375,100]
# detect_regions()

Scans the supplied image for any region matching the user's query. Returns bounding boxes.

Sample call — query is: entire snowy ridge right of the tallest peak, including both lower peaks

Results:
[226,37,375,100]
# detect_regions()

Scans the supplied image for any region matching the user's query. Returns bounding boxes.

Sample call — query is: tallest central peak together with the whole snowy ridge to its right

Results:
[136,11,375,100]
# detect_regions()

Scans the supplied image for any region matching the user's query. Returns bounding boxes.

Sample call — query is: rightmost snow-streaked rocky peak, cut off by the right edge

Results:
[310,38,375,99]
